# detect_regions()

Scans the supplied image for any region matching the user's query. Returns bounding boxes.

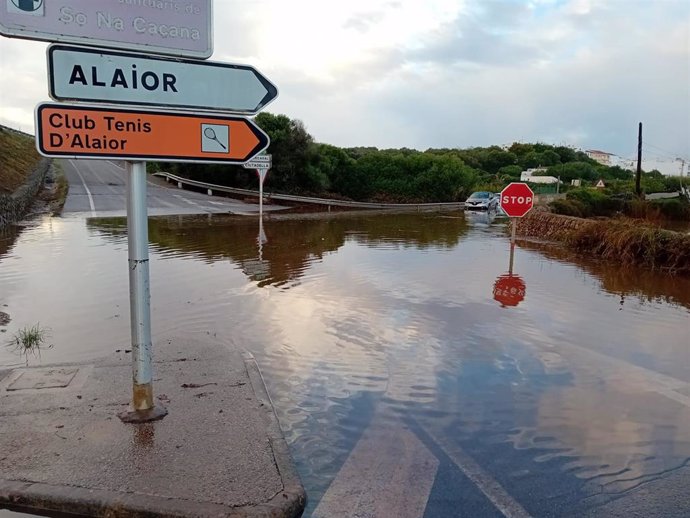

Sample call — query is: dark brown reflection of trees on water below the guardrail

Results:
[88,214,467,286]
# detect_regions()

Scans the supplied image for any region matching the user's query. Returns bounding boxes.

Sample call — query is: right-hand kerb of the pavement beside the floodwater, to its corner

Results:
[242,350,307,518]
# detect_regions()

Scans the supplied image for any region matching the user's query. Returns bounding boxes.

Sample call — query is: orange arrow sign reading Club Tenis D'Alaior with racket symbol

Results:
[36,103,270,164]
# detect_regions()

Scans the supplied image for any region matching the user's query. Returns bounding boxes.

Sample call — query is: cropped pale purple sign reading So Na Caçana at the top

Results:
[0,0,213,59]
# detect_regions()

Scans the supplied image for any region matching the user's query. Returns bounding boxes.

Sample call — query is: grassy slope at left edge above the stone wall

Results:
[0,126,41,194]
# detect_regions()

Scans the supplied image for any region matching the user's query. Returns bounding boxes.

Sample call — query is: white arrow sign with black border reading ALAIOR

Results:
[46,45,278,115]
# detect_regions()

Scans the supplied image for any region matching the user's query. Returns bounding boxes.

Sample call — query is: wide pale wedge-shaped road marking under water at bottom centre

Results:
[312,416,439,518]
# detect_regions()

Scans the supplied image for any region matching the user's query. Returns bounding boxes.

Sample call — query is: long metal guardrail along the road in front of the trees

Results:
[154,171,465,211]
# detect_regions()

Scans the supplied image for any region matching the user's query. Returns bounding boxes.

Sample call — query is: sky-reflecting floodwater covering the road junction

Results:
[0,212,690,517]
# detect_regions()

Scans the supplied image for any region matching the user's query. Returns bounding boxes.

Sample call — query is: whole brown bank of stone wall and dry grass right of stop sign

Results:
[517,211,690,275]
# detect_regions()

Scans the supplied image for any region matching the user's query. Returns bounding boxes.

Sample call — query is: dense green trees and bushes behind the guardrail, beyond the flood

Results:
[157,112,684,217]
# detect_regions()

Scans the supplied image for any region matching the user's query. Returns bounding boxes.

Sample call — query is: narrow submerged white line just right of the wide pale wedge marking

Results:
[420,423,531,518]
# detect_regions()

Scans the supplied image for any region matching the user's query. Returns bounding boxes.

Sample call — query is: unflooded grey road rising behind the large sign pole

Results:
[60,159,282,217]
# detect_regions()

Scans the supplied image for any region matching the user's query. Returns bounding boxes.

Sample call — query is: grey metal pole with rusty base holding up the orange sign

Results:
[119,162,168,423]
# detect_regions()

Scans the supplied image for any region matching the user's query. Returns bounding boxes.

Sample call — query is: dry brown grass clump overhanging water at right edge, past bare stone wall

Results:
[565,219,690,274]
